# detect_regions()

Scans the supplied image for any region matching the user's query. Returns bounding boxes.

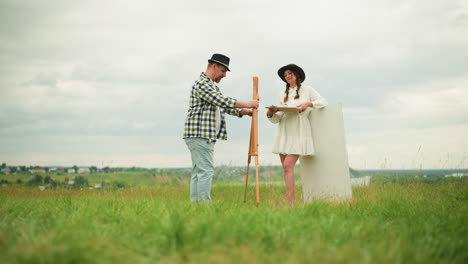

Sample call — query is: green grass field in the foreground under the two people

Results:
[0,176,468,264]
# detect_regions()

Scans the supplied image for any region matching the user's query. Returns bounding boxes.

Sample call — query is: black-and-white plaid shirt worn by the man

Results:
[183,72,241,141]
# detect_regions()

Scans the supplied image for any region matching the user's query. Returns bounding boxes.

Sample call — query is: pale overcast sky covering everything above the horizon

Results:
[0,0,468,169]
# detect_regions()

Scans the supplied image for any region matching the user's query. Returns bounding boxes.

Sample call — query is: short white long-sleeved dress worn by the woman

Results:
[268,85,327,156]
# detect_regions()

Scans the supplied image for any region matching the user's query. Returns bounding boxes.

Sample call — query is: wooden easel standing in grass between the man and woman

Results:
[244,77,260,205]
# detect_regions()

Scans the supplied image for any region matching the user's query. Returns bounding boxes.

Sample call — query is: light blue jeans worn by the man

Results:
[184,138,215,202]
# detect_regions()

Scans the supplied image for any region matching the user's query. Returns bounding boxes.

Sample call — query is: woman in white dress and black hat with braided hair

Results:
[267,64,327,204]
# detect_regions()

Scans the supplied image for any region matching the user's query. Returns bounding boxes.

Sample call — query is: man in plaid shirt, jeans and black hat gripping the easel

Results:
[184,54,258,202]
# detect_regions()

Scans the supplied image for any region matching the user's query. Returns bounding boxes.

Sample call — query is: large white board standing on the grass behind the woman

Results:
[300,104,352,202]
